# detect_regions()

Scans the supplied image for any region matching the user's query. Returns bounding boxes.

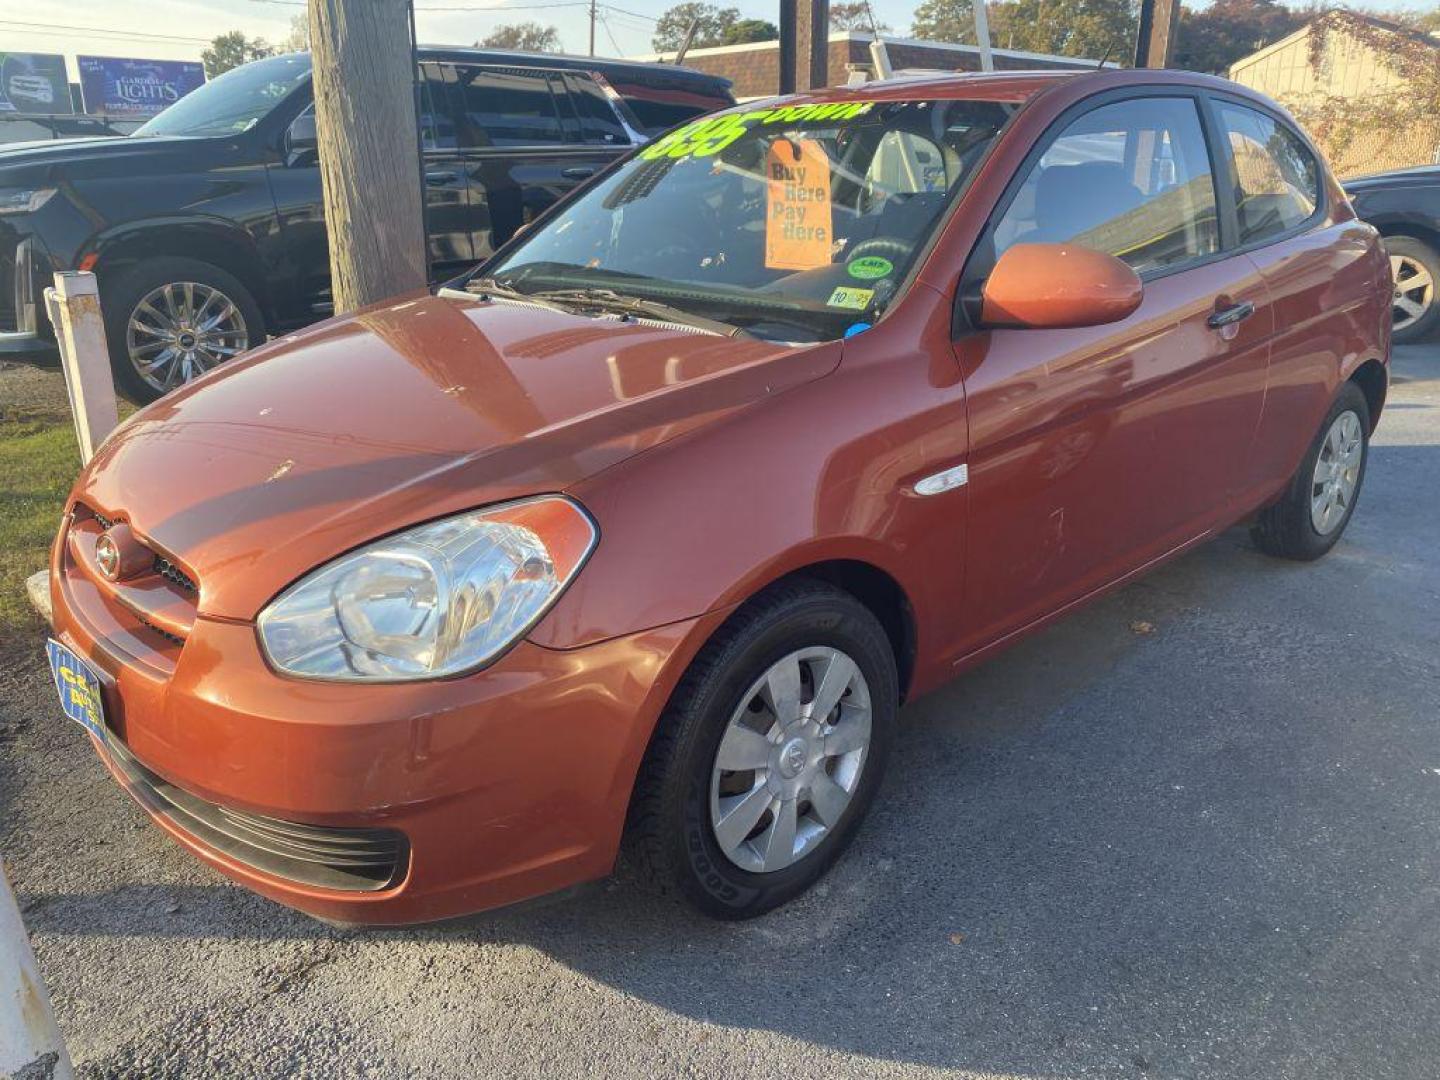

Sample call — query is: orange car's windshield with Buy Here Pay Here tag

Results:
[483,99,1015,341]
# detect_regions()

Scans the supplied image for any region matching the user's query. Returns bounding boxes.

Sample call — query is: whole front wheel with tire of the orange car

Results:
[626,582,899,919]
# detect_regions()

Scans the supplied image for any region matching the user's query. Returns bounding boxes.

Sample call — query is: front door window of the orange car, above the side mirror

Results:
[995,98,1220,272]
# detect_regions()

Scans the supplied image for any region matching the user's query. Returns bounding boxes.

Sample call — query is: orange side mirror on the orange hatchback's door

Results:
[981,243,1145,330]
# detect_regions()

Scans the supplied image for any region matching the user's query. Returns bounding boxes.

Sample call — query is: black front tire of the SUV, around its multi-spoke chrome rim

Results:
[99,256,265,405]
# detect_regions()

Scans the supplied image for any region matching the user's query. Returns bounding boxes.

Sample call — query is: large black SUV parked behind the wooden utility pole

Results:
[0,48,733,402]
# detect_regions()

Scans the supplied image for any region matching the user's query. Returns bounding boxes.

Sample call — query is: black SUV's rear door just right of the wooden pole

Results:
[454,63,625,259]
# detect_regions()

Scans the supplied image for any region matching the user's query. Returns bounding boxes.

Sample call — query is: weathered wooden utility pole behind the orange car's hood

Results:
[310,0,428,314]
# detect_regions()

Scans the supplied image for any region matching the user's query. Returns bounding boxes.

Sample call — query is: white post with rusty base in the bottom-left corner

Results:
[0,860,75,1080]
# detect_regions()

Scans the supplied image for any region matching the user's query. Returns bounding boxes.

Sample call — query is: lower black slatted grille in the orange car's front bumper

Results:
[105,734,410,893]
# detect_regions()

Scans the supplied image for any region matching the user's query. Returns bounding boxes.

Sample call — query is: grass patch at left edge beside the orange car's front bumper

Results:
[0,406,81,639]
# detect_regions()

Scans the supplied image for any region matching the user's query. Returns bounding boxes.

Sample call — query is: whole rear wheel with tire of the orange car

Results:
[1250,383,1369,560]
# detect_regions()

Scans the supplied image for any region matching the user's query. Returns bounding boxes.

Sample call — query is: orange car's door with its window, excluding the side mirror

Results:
[955,91,1270,656]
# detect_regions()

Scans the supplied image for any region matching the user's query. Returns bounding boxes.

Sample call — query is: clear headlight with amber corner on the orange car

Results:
[259,495,599,683]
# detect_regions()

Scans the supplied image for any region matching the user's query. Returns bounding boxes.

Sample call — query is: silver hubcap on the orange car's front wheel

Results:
[710,647,870,873]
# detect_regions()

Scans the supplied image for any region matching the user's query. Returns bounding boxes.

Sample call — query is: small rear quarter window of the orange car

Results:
[1220,102,1320,243]
